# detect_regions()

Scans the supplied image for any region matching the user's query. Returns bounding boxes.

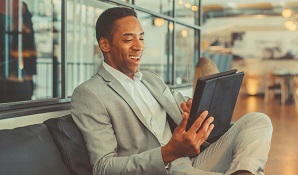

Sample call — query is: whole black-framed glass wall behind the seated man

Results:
[0,0,200,106]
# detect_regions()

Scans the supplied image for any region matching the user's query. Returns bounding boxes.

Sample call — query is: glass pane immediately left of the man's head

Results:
[66,0,110,96]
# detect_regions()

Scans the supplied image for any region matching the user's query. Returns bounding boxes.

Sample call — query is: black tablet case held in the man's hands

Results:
[186,69,244,143]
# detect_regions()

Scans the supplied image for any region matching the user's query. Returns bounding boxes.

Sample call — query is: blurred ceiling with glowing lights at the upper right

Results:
[202,0,298,34]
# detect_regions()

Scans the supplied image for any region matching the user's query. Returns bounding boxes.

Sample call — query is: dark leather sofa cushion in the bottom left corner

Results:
[0,124,70,175]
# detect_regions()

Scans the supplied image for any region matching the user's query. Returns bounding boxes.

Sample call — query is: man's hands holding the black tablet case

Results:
[161,99,214,164]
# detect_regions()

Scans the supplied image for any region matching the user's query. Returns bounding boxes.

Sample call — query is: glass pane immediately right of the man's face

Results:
[137,11,173,84]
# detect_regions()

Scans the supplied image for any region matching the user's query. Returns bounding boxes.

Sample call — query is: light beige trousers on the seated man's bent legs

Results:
[170,112,273,175]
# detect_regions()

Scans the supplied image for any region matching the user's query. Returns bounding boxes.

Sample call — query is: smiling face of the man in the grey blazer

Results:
[105,16,144,78]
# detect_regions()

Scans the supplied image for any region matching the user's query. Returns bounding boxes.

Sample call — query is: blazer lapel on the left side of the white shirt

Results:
[97,65,150,130]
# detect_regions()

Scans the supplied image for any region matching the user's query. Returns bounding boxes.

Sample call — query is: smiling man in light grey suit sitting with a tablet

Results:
[71,7,272,175]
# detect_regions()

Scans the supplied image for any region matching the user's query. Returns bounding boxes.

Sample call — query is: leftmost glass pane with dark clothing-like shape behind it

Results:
[0,0,61,103]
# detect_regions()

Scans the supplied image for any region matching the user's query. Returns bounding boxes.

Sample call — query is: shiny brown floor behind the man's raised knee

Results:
[233,96,298,175]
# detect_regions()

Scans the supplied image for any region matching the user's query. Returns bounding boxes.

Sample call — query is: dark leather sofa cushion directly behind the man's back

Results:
[44,114,92,175]
